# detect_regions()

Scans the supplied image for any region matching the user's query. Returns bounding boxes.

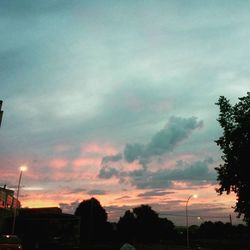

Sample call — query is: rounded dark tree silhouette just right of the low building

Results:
[75,198,108,242]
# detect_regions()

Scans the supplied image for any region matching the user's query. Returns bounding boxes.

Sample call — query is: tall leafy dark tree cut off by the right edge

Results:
[215,92,250,224]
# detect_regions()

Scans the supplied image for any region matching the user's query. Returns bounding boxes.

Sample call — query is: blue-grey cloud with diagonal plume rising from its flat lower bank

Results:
[98,117,215,188]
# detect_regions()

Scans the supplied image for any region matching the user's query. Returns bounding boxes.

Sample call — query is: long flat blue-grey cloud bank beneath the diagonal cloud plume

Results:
[99,155,216,189]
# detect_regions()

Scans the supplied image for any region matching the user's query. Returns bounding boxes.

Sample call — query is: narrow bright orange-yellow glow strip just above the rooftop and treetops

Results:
[21,186,236,209]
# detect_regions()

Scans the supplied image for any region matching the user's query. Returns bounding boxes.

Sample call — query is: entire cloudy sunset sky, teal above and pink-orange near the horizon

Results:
[0,0,250,225]
